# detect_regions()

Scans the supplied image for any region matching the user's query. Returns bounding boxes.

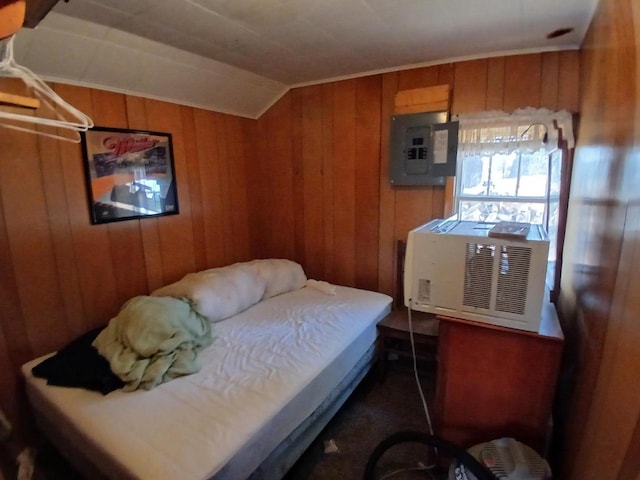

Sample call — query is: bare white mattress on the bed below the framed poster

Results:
[22,287,391,480]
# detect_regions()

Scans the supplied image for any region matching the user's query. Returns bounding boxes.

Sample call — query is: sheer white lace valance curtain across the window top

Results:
[452,107,574,155]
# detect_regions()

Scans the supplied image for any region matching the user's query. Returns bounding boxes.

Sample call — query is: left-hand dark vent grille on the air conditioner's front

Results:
[462,243,495,309]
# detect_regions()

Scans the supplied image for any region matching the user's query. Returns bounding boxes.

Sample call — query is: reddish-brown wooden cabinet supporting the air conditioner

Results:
[435,304,564,453]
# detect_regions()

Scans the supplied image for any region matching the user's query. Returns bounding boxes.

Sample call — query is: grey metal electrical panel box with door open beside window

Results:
[389,112,458,185]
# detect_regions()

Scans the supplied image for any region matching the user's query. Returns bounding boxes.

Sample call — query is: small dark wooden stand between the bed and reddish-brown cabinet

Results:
[378,308,438,380]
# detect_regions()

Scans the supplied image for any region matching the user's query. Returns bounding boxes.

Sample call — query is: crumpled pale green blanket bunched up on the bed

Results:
[93,296,214,391]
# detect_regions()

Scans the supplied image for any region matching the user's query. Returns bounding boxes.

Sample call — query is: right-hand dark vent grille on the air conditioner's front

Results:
[495,245,531,315]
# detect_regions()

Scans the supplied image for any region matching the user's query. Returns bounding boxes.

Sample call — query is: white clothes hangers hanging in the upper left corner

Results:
[0,34,93,143]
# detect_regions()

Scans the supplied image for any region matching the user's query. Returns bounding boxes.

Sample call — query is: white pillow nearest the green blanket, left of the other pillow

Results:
[151,263,267,322]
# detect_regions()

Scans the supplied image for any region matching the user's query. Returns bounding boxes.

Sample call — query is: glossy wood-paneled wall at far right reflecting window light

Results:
[558,0,640,480]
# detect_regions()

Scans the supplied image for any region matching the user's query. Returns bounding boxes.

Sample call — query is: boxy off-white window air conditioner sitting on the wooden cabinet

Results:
[404,219,549,332]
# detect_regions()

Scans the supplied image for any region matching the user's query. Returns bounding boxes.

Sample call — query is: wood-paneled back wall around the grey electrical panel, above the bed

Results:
[249,51,579,300]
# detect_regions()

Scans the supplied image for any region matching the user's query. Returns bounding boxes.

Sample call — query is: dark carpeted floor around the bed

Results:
[26,361,447,480]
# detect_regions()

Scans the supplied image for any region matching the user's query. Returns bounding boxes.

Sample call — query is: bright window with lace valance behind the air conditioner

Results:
[454,109,573,296]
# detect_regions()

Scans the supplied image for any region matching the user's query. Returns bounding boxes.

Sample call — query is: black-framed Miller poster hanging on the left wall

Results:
[82,127,179,224]
